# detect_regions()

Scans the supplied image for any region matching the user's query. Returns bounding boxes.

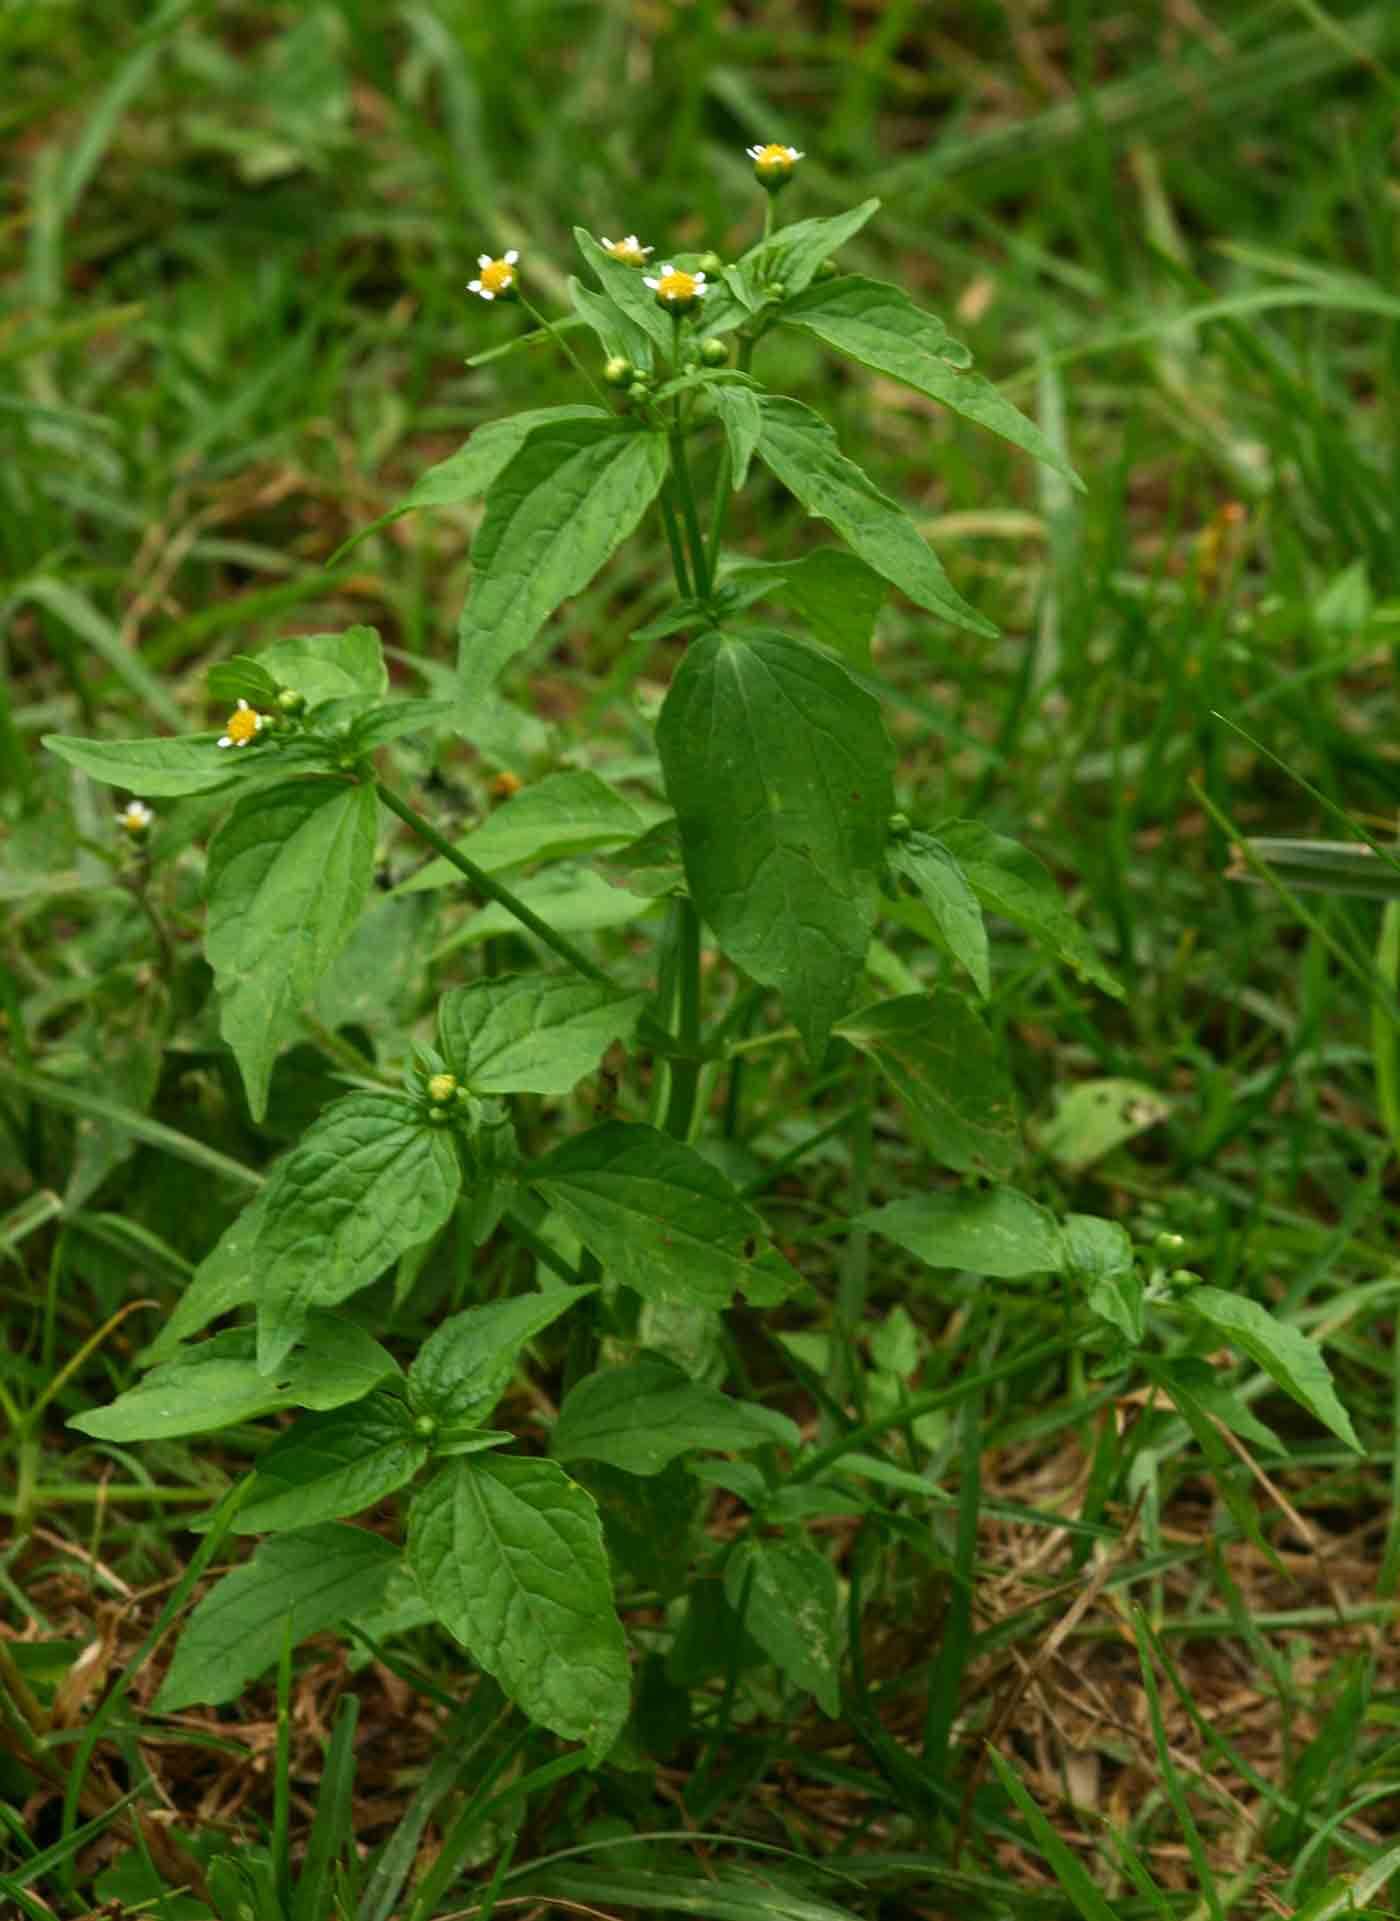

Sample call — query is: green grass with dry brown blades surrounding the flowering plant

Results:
[0,0,1400,1921]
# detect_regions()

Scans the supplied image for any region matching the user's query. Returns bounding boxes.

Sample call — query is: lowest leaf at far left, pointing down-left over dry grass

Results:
[154,1521,399,1714]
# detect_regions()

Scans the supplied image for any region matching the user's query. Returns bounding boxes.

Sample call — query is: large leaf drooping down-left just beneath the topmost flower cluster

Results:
[457,417,666,703]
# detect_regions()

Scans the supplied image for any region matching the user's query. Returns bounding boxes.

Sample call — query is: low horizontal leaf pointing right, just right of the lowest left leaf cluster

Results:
[549,1360,801,1473]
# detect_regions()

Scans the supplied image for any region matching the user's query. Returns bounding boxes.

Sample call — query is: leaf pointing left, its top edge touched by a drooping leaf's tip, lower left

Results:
[69,1314,398,1441]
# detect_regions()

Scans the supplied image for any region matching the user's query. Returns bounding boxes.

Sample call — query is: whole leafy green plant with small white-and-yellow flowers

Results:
[48,144,1348,1758]
